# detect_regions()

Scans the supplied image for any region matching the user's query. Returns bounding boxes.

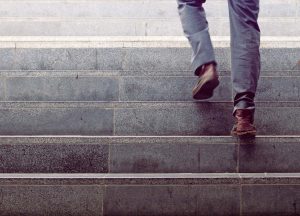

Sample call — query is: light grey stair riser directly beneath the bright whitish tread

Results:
[0,47,300,71]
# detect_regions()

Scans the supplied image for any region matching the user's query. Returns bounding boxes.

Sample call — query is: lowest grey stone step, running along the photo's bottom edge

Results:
[0,173,300,216]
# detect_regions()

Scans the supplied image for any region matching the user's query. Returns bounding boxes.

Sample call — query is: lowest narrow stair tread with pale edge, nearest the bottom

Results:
[0,173,300,185]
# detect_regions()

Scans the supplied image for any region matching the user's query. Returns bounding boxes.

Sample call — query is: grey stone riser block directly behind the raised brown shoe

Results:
[120,76,232,101]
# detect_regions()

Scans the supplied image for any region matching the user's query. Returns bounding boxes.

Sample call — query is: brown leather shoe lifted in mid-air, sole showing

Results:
[193,63,219,100]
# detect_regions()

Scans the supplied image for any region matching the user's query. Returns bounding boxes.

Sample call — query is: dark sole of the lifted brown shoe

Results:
[193,79,220,100]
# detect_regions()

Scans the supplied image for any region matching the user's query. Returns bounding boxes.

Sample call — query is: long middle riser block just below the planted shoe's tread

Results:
[110,143,237,173]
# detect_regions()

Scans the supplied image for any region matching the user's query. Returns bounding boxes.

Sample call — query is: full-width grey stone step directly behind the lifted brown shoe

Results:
[0,70,300,102]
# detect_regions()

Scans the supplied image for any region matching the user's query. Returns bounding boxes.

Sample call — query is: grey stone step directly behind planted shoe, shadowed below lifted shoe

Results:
[0,101,300,136]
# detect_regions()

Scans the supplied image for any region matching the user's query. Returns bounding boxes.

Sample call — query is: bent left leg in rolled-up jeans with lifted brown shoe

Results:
[177,0,219,99]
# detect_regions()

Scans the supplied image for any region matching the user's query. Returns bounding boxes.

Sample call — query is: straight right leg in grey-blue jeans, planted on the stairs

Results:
[228,0,260,133]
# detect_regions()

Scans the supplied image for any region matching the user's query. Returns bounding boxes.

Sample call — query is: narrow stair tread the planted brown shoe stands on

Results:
[0,135,300,144]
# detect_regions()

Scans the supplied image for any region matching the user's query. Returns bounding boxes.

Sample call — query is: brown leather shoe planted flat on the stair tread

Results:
[231,109,256,137]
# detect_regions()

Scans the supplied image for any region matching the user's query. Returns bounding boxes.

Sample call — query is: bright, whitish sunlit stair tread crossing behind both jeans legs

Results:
[0,36,300,48]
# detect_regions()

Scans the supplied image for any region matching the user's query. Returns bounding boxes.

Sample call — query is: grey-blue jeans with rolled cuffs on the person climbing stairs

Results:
[177,0,260,113]
